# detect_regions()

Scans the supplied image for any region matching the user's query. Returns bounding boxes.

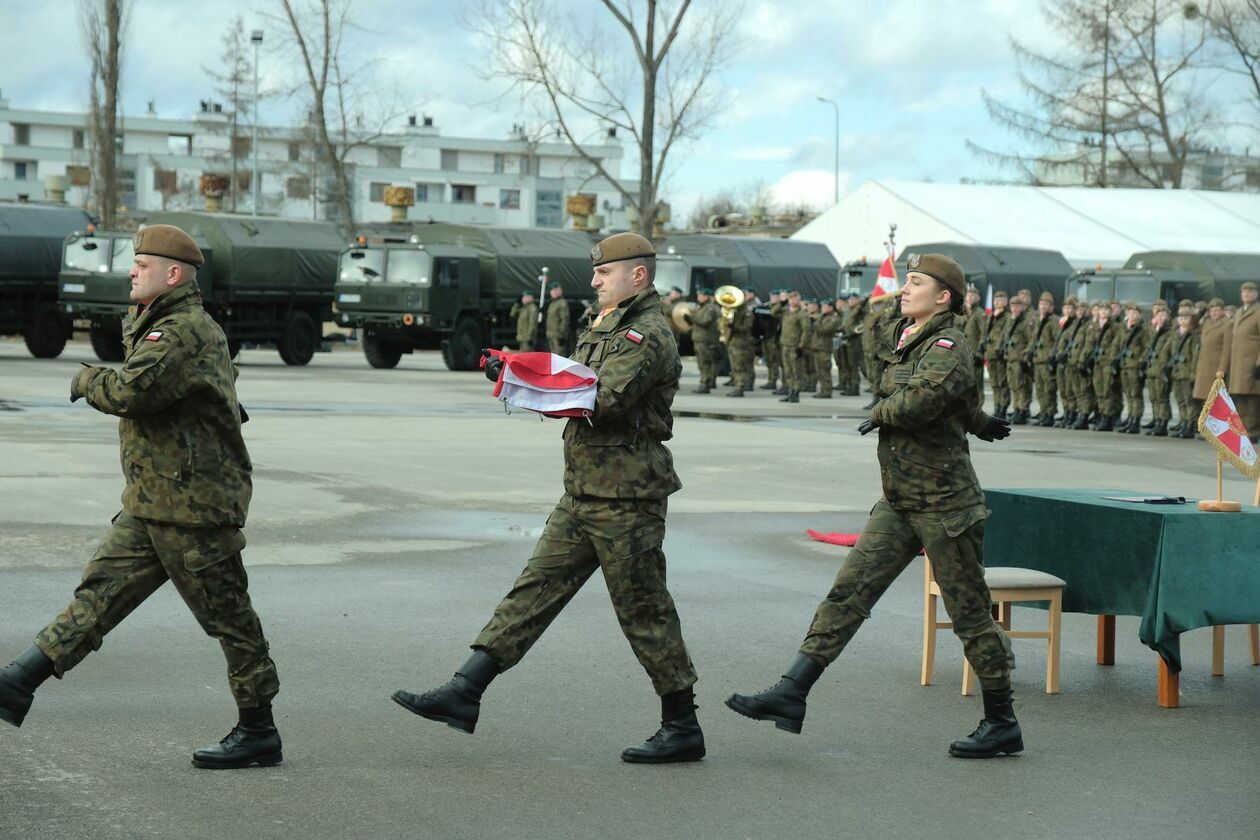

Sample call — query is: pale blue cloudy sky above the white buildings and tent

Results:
[0,0,1047,218]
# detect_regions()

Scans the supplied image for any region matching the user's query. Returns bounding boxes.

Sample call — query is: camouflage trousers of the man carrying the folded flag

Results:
[473,494,696,695]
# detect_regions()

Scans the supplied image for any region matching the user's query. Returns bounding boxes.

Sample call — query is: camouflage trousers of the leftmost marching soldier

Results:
[35,511,280,709]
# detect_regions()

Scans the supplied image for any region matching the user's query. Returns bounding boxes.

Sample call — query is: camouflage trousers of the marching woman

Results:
[800,499,1014,689]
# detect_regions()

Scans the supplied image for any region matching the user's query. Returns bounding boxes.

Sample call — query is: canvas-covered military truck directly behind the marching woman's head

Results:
[897,242,1072,306]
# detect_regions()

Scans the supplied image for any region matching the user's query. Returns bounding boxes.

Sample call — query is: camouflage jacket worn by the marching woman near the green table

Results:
[871,312,989,516]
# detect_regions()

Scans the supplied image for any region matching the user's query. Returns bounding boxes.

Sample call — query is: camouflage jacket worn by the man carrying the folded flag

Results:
[564,286,683,499]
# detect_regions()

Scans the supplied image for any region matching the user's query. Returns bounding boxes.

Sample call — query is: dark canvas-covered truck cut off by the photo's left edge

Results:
[0,201,92,359]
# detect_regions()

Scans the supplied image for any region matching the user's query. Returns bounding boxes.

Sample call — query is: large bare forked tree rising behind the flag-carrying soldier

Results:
[465,0,740,236]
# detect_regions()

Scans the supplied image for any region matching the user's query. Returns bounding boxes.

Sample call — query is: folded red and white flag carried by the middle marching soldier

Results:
[481,349,597,417]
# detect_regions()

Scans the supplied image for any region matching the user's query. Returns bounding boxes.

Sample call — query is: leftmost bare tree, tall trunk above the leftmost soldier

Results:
[79,0,126,229]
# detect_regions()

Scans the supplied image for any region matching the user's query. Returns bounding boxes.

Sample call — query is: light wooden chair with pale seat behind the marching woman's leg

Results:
[920,557,1066,695]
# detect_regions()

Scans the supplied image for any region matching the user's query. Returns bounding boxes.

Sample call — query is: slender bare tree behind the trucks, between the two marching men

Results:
[268,0,410,234]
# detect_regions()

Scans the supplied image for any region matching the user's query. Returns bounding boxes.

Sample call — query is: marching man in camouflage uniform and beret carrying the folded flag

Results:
[393,233,704,763]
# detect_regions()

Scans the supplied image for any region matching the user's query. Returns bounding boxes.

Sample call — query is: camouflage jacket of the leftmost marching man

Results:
[72,283,253,528]
